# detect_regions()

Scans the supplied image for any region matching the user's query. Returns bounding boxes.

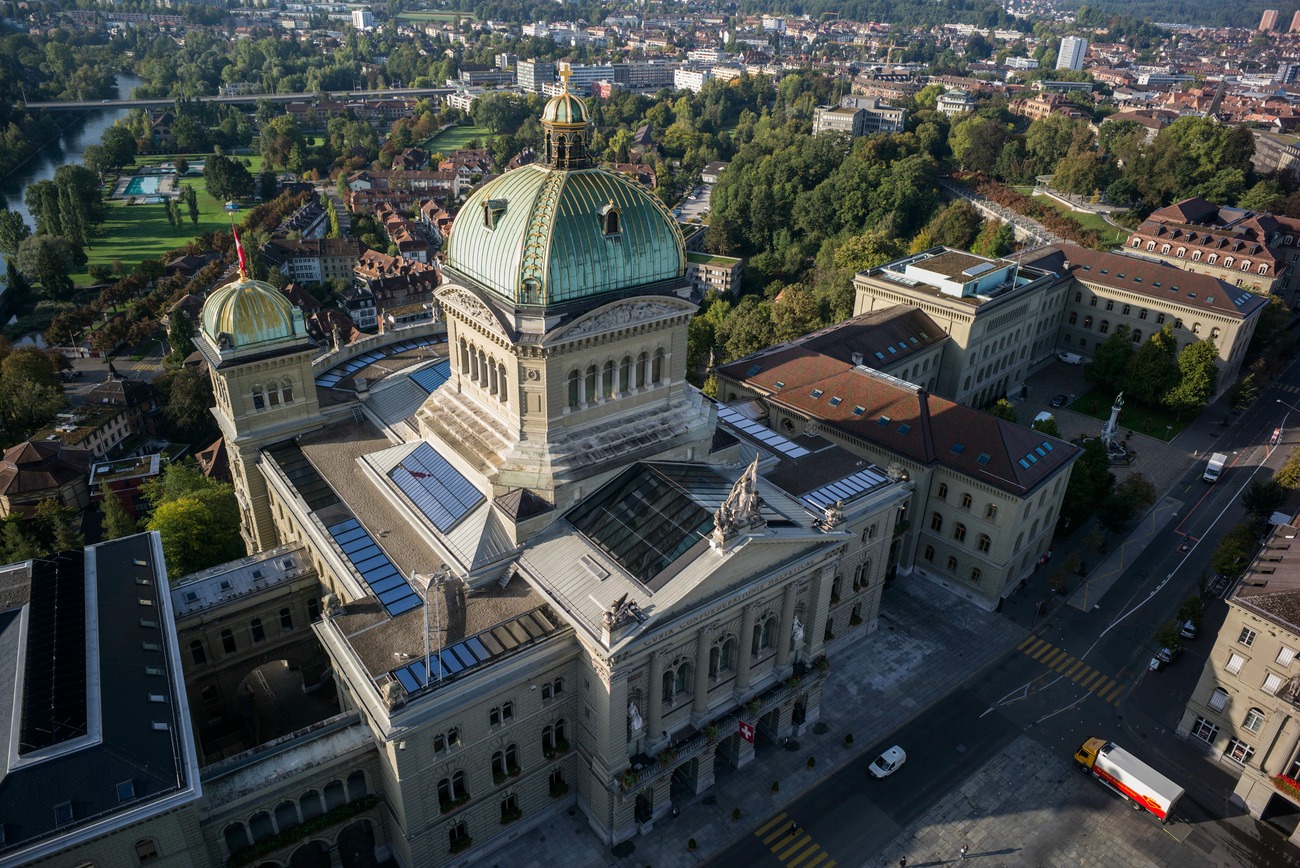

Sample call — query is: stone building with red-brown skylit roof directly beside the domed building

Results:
[718,305,1080,608]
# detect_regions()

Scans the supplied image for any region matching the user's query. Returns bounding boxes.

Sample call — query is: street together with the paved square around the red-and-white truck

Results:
[709,368,1300,868]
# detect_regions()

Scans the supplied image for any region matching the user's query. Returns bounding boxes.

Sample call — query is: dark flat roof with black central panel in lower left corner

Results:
[0,534,199,865]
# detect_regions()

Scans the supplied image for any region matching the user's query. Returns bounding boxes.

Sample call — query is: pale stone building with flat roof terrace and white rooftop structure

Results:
[853,247,1066,407]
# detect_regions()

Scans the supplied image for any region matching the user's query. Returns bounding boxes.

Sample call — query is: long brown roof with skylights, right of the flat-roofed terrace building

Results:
[1022,244,1269,320]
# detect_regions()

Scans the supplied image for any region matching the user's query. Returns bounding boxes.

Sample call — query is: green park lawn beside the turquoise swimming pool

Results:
[73,184,244,285]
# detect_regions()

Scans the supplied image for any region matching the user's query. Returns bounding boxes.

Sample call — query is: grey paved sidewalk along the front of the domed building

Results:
[501,578,1024,868]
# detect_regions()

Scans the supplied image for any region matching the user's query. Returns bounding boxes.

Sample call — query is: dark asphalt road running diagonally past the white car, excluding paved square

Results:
[709,358,1300,865]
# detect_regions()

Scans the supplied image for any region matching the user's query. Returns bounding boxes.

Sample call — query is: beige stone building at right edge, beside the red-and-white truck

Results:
[1178,511,1300,843]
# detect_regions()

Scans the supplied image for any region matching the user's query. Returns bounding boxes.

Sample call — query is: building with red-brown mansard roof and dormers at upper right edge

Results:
[1125,196,1300,301]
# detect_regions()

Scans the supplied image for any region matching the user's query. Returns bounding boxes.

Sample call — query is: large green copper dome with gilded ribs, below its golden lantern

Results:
[446,164,686,304]
